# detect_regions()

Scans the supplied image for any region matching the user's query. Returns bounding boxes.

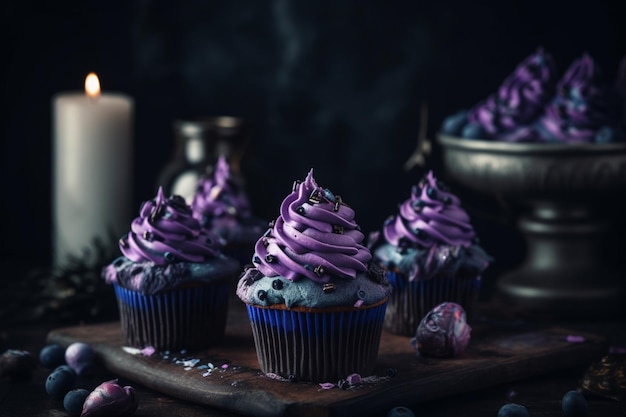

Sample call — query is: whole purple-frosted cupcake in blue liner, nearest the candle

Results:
[102,188,240,350]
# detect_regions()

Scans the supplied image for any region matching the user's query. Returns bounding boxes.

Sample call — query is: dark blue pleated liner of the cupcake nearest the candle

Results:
[114,282,229,350]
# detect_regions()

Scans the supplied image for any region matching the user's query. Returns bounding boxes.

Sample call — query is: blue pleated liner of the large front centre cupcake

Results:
[247,302,387,382]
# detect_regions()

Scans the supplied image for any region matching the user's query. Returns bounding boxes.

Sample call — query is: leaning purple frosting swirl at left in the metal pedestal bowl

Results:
[468,48,556,142]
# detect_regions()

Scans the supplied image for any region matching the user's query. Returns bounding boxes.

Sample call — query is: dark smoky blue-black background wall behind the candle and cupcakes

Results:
[0,0,626,300]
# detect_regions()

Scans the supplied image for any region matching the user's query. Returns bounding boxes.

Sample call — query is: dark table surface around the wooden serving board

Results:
[0,300,626,417]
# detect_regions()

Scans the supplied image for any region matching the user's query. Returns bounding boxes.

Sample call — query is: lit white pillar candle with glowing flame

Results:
[52,73,134,266]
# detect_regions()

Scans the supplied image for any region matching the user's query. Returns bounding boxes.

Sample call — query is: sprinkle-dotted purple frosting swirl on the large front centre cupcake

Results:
[253,170,372,283]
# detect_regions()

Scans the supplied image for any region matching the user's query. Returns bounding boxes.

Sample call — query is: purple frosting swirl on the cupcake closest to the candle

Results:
[119,187,220,265]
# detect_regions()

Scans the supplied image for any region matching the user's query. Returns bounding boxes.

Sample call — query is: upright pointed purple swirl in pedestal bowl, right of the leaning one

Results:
[536,54,622,143]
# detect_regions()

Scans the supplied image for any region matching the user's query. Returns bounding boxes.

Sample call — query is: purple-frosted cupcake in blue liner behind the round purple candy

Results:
[369,171,490,336]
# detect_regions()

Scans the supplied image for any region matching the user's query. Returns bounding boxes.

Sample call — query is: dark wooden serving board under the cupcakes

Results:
[47,300,607,417]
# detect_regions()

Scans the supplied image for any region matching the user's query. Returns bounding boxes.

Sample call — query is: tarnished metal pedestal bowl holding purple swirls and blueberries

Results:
[438,135,626,318]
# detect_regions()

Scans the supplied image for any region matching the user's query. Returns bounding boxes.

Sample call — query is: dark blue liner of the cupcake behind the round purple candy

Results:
[384,272,481,336]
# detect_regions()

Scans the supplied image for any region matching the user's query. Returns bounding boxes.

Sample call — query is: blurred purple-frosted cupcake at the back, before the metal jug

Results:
[191,156,267,264]
